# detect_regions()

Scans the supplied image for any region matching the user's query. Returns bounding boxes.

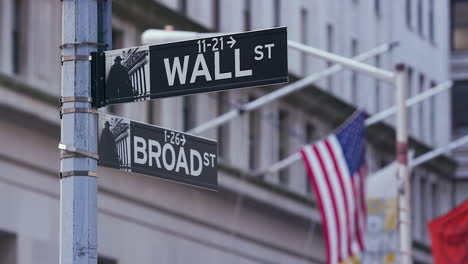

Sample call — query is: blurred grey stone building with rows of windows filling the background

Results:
[0,0,468,264]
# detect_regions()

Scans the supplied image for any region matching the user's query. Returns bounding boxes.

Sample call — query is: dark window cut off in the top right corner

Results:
[451,0,468,50]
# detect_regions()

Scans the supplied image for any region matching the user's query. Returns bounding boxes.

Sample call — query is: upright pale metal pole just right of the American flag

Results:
[395,64,412,264]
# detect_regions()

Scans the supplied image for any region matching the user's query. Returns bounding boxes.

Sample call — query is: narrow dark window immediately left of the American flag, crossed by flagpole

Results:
[278,110,289,186]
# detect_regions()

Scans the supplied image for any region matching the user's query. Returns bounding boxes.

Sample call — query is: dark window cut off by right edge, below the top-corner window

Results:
[452,80,468,137]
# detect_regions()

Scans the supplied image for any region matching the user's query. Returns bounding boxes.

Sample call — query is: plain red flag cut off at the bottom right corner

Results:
[428,200,468,264]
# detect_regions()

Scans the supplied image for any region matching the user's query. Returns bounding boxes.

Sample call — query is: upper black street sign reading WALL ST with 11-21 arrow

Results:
[94,27,288,107]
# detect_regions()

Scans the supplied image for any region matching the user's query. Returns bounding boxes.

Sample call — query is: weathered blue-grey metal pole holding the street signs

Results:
[60,0,98,264]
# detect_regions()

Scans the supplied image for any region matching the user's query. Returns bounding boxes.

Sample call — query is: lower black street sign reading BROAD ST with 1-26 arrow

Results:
[98,113,218,190]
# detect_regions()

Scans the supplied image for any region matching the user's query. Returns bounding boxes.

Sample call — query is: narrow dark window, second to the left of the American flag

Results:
[248,97,261,170]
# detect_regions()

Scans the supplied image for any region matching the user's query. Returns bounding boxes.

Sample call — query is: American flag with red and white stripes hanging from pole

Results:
[301,112,367,264]
